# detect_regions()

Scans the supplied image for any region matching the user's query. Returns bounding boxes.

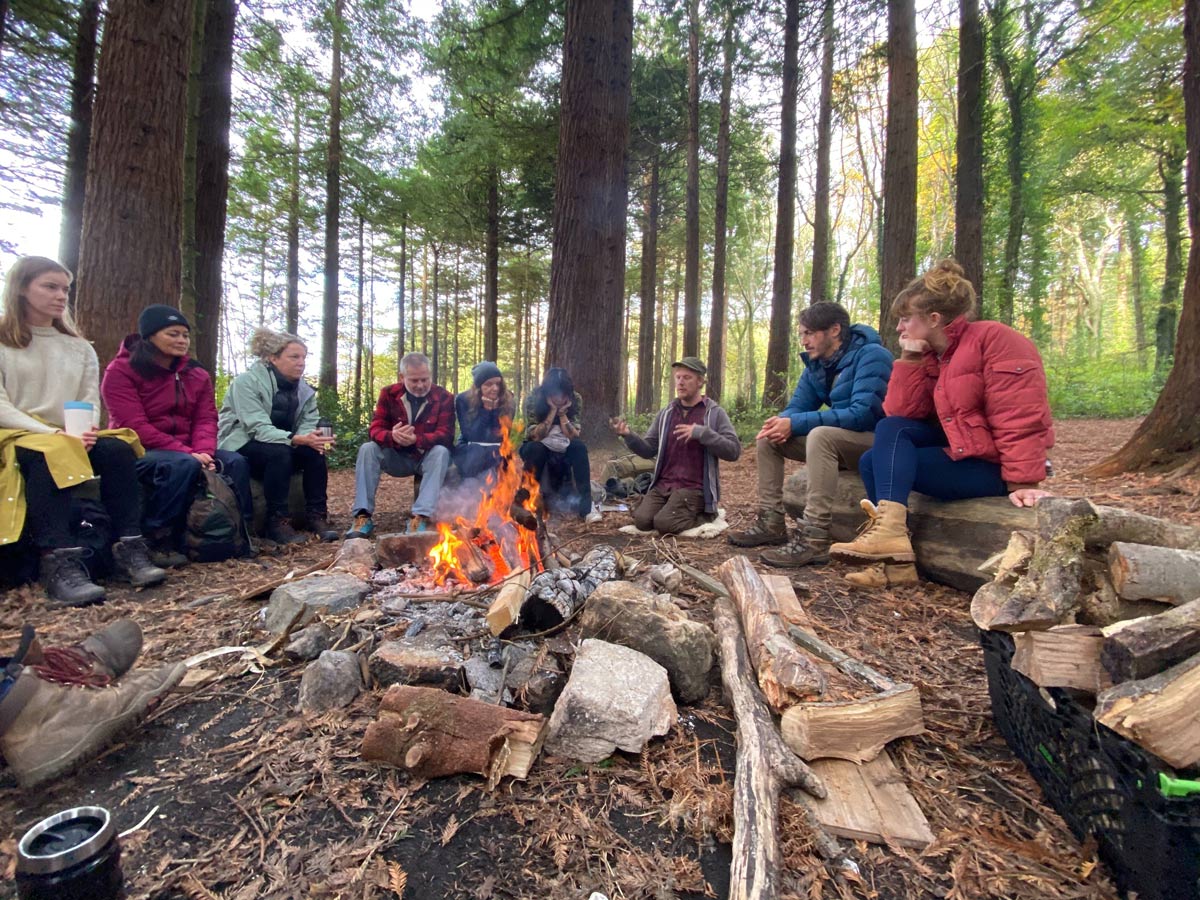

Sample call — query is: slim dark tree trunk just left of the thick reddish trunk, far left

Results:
[58,0,101,294]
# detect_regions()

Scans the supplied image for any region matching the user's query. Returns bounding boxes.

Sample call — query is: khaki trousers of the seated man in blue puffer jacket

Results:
[758,425,875,529]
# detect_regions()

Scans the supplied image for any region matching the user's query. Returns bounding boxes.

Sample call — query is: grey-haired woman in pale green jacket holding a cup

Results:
[217,328,337,544]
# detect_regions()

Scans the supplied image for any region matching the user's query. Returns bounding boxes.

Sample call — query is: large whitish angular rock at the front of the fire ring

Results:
[546,640,676,762]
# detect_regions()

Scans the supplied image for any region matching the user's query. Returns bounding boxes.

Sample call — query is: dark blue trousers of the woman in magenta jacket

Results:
[137,450,254,533]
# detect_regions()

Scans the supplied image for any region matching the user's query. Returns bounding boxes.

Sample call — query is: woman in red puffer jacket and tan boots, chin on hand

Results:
[829,259,1054,573]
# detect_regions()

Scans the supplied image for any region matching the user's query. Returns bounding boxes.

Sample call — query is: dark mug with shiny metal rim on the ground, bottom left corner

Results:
[17,806,125,900]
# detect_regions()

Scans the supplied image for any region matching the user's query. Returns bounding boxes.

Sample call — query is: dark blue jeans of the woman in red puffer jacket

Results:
[858,415,1008,505]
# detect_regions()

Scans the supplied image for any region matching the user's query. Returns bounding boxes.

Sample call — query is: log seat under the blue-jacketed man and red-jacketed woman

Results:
[784,469,1037,592]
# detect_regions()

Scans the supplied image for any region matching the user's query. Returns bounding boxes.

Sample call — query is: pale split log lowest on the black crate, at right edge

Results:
[1094,655,1200,768]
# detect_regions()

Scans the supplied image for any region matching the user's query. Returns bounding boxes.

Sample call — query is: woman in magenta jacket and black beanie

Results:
[100,305,253,563]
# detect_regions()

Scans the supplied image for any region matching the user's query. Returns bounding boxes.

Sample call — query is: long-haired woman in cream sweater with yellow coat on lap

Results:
[0,257,167,606]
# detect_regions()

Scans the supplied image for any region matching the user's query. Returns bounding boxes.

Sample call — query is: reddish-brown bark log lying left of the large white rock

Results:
[362,684,546,788]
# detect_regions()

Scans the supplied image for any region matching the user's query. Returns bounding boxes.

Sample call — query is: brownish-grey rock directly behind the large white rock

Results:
[580,581,715,703]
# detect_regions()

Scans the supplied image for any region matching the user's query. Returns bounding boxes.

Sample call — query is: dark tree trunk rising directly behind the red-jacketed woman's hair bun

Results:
[954,0,984,305]
